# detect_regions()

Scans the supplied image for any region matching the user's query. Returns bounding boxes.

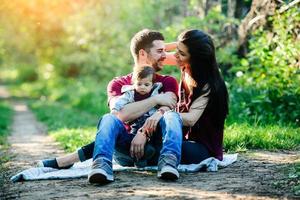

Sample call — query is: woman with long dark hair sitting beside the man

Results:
[42,30,228,177]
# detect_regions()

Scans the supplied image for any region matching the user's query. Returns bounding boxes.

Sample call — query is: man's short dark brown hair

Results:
[130,29,165,61]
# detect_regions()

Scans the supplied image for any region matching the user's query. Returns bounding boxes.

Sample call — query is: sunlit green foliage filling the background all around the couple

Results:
[0,0,300,153]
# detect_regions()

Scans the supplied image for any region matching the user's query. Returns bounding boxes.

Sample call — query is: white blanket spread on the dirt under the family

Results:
[10,154,238,182]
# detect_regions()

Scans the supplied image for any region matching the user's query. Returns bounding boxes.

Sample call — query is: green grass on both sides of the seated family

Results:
[30,98,300,152]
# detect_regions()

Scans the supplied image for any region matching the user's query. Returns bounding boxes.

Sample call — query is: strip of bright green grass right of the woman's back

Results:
[224,123,300,151]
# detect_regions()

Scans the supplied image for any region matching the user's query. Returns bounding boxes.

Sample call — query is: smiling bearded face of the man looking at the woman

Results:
[147,40,166,71]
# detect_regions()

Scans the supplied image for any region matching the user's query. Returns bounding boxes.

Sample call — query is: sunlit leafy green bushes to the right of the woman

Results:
[230,8,300,124]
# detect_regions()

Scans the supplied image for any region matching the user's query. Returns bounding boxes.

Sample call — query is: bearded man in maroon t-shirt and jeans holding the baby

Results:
[88,30,182,183]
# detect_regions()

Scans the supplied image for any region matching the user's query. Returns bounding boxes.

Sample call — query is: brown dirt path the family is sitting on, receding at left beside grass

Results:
[0,86,300,199]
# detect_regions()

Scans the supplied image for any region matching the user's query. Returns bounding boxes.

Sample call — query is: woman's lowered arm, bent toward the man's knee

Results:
[180,91,210,127]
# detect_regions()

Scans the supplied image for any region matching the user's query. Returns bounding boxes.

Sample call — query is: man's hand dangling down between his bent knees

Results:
[130,129,147,159]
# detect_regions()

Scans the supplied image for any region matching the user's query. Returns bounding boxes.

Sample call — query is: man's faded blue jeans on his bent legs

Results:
[93,111,182,164]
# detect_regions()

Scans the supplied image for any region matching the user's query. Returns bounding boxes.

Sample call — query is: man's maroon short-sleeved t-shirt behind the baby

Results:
[107,73,178,104]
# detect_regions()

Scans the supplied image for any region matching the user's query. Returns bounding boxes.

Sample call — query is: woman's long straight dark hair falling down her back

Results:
[178,30,228,129]
